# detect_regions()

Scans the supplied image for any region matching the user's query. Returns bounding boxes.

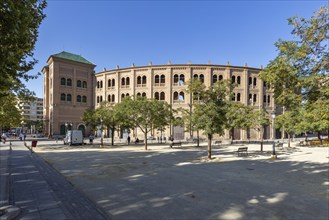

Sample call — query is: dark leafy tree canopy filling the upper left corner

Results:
[0,0,47,98]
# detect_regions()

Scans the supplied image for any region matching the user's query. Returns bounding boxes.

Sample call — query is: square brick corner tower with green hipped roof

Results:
[42,51,96,137]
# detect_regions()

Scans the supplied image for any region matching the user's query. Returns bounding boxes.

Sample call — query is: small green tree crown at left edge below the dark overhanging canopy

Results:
[0,94,21,128]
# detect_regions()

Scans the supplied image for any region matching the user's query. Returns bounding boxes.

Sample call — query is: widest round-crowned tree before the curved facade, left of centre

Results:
[117,97,172,150]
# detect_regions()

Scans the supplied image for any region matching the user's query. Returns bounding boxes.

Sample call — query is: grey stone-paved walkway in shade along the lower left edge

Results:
[0,141,110,219]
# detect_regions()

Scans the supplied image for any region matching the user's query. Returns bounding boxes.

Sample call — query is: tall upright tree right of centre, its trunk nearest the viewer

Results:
[188,80,231,159]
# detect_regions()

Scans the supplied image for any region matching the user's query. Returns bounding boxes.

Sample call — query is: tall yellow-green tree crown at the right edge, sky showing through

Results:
[261,6,329,141]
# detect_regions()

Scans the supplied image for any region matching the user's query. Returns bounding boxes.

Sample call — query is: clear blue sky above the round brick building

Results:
[27,0,328,98]
